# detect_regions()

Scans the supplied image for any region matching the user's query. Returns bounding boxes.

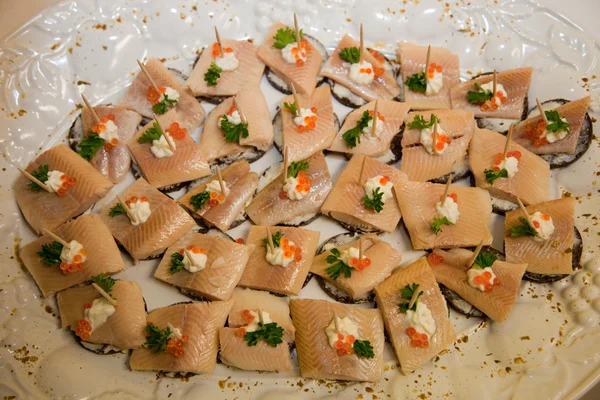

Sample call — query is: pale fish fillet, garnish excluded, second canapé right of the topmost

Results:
[396,43,460,110]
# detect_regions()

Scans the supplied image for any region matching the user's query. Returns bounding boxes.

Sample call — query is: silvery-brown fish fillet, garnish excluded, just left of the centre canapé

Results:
[179,160,258,231]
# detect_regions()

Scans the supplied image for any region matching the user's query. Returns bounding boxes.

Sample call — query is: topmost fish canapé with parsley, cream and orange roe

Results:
[258,22,323,96]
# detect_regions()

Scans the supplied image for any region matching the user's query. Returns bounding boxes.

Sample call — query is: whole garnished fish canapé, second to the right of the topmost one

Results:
[396,43,460,110]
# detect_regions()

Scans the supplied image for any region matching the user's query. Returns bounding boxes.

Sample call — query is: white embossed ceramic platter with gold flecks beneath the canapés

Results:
[0,0,600,400]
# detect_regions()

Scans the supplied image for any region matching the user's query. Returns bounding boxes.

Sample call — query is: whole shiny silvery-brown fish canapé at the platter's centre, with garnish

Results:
[246,152,332,225]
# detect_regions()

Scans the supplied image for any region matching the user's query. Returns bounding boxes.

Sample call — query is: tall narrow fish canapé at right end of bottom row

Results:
[376,257,456,375]
